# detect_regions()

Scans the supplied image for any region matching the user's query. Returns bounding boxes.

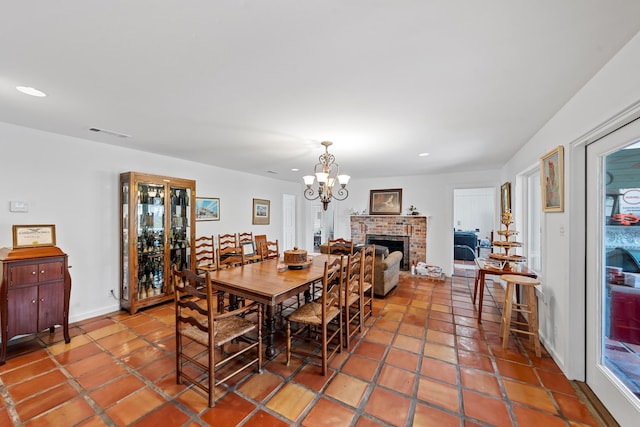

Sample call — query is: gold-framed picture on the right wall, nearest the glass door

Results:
[540,145,564,212]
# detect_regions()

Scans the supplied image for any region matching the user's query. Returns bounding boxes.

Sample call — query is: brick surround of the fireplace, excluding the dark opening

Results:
[351,215,427,265]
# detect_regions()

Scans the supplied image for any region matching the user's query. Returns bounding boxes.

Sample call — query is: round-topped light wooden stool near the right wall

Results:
[500,274,540,357]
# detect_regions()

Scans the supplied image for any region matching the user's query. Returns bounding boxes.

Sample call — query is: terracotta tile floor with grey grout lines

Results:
[0,270,598,427]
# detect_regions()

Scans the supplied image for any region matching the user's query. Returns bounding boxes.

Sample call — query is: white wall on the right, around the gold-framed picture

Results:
[502,30,640,380]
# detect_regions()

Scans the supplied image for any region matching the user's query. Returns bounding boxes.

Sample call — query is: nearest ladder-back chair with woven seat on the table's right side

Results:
[287,257,343,375]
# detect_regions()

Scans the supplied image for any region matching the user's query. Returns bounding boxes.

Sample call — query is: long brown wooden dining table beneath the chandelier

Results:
[209,255,337,358]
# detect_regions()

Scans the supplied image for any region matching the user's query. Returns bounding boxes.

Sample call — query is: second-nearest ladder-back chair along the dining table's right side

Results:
[342,251,364,350]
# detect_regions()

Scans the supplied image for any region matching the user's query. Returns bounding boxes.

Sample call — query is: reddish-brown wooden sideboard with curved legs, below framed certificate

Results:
[0,246,71,365]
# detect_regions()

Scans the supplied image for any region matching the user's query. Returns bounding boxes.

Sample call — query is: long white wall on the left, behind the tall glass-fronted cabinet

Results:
[0,122,300,322]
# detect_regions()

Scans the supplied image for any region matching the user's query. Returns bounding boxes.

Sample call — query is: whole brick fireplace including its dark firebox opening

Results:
[351,215,427,270]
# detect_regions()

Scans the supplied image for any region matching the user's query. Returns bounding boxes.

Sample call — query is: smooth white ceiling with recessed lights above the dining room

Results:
[0,0,640,181]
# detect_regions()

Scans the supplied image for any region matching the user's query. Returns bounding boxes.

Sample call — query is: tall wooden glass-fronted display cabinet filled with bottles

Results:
[120,172,196,314]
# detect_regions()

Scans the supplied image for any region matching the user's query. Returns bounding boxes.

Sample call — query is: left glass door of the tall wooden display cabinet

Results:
[137,183,166,299]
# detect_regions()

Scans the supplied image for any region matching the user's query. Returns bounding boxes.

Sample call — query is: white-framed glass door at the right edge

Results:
[586,115,640,426]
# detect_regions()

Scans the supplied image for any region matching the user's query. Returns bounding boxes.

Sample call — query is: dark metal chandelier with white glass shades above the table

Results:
[302,141,351,211]
